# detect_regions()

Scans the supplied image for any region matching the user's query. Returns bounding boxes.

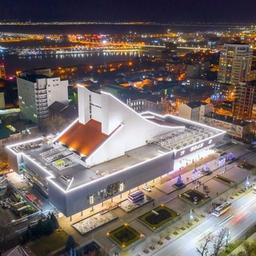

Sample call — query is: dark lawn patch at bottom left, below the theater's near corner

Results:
[29,230,68,256]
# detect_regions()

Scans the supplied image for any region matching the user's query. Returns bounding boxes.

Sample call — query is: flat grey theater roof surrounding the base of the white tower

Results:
[12,113,221,190]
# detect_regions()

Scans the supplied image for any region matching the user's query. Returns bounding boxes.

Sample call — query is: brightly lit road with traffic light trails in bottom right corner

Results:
[154,192,256,256]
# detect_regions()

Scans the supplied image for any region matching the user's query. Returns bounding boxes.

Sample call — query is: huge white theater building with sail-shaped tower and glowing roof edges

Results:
[7,85,224,216]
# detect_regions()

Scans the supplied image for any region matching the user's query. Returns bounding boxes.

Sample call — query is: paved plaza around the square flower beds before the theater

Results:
[56,144,256,255]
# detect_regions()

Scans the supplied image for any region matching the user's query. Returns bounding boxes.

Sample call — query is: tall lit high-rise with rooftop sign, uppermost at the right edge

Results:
[218,44,253,86]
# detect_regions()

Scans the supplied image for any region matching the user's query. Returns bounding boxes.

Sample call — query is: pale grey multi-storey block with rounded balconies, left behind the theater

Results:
[17,73,68,123]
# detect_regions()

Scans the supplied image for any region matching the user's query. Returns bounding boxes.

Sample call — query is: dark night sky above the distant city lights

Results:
[0,0,256,22]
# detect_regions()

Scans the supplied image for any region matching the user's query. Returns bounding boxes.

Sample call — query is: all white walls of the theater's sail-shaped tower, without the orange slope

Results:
[78,87,172,166]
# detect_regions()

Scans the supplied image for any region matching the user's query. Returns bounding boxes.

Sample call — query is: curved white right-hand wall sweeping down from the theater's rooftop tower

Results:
[86,94,172,166]
